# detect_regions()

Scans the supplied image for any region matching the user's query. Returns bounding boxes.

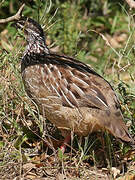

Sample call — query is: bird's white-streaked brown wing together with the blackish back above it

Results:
[22,54,113,110]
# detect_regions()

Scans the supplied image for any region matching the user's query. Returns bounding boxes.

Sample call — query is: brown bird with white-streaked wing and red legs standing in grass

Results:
[15,16,134,152]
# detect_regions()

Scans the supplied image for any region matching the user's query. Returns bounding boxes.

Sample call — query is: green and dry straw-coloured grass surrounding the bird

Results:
[0,0,135,179]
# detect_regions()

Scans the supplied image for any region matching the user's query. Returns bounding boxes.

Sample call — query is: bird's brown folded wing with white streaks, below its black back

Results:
[41,62,108,110]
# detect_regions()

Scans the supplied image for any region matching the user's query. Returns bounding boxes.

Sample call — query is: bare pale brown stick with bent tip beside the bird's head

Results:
[0,4,25,24]
